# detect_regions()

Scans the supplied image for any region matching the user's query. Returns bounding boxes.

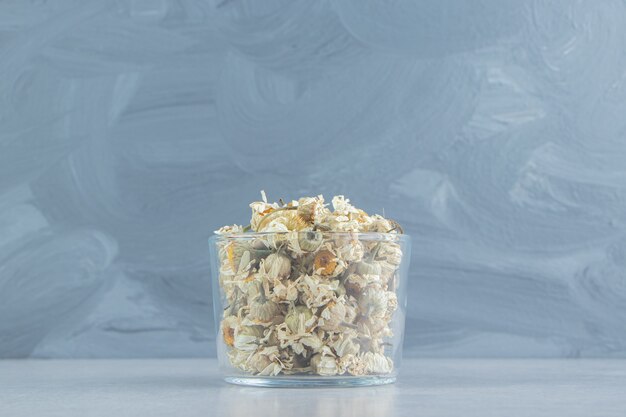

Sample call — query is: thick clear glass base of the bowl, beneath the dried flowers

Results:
[224,375,396,388]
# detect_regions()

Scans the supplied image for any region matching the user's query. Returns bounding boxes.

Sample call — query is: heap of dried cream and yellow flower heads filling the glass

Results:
[216,192,402,376]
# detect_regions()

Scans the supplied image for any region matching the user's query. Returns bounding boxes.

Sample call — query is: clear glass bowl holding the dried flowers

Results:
[209,231,411,387]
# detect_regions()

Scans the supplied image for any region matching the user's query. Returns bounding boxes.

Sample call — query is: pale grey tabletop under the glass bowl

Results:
[0,359,626,417]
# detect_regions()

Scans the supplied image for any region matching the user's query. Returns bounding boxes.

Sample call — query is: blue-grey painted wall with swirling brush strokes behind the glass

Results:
[0,0,626,357]
